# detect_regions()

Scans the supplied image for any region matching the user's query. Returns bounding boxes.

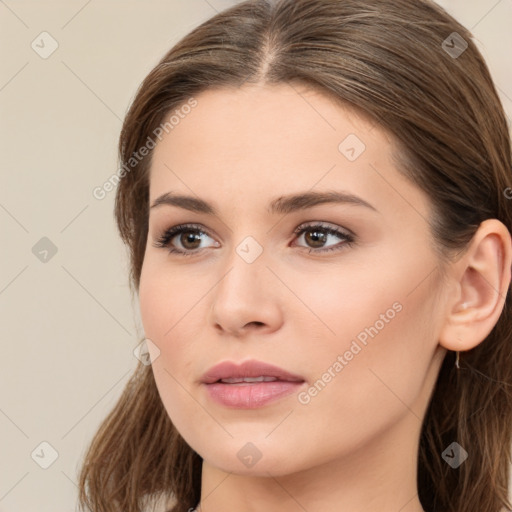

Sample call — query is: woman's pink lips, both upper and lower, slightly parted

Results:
[201,361,305,409]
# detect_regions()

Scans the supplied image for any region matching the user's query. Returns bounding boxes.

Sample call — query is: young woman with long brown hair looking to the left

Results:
[76,0,512,512]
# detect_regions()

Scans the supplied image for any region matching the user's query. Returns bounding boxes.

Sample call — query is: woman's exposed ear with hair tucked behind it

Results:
[439,219,512,351]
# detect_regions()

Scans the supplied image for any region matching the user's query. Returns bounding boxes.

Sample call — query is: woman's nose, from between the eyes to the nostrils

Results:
[210,246,283,338]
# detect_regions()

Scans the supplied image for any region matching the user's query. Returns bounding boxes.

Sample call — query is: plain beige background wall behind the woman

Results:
[0,0,512,512]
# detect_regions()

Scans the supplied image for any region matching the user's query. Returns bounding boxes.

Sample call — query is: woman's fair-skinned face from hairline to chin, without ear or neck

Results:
[139,85,447,475]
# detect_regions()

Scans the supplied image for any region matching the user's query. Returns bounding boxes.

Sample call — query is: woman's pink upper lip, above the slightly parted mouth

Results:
[201,360,304,384]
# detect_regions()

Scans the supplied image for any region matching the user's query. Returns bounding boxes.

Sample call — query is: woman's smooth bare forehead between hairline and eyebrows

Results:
[150,84,427,222]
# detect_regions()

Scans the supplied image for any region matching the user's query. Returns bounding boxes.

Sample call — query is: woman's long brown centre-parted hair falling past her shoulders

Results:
[76,0,512,512]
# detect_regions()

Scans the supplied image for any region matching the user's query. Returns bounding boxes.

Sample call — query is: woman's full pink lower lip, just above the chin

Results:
[206,380,304,409]
